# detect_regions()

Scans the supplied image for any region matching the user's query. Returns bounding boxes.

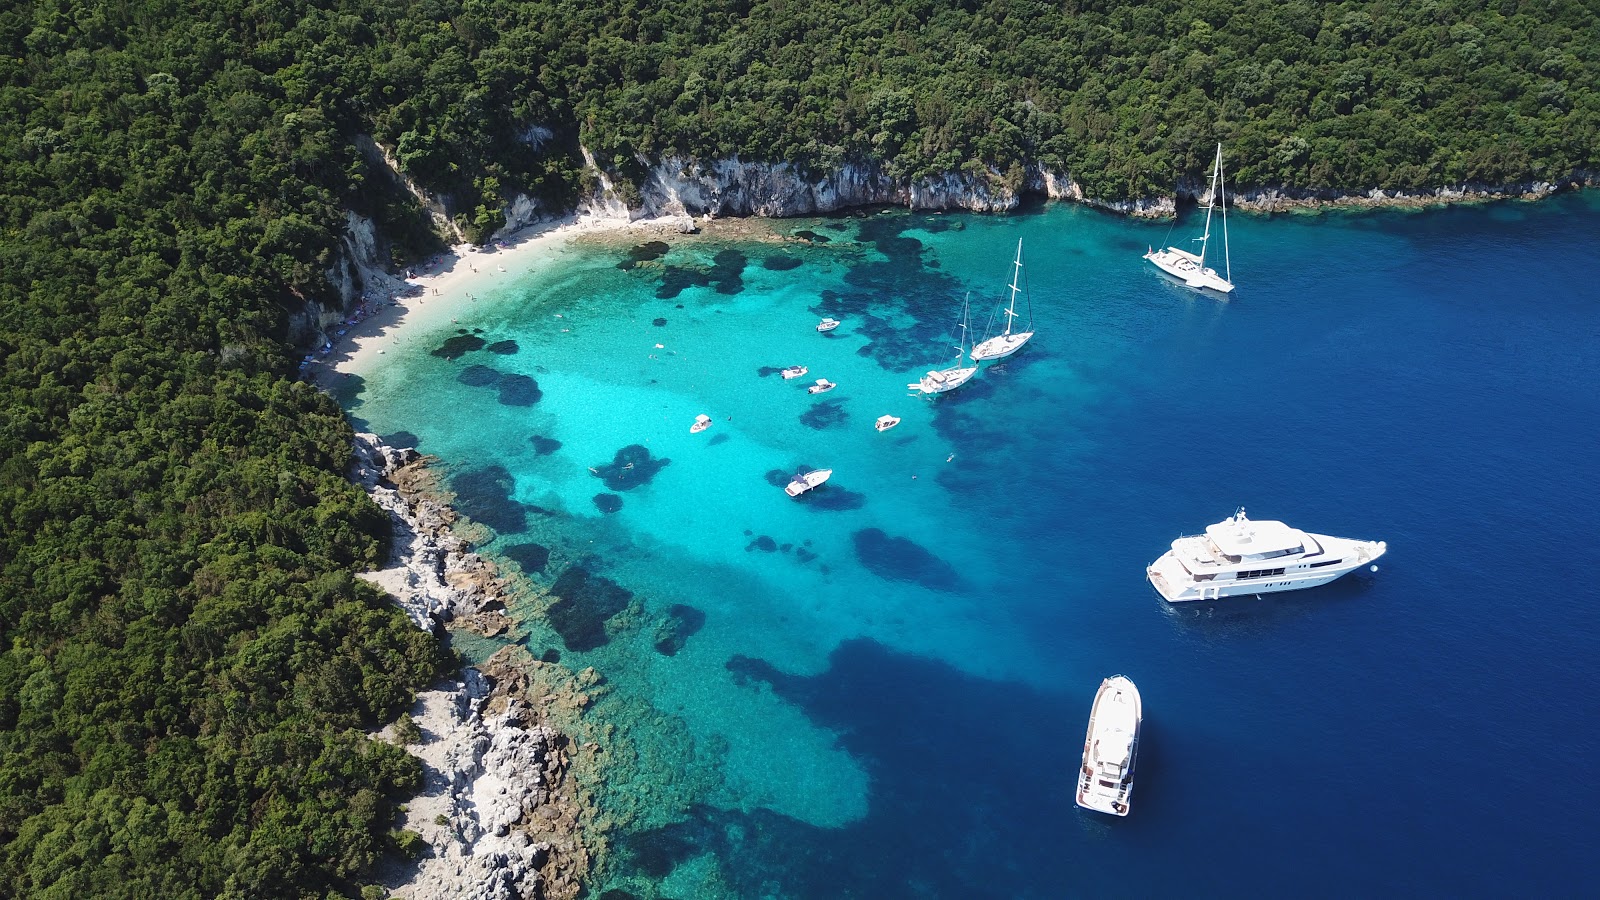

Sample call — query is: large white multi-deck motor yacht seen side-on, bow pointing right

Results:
[1146,506,1389,604]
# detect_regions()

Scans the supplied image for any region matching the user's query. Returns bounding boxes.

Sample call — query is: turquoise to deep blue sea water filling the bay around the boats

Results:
[344,194,1600,898]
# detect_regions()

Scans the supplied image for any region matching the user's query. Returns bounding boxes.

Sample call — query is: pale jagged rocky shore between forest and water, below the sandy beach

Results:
[352,434,598,900]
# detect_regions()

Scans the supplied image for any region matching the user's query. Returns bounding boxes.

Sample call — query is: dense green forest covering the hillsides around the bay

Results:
[0,0,1600,898]
